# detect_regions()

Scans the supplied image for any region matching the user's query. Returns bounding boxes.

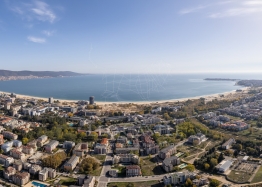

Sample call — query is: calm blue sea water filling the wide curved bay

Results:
[0,74,262,102]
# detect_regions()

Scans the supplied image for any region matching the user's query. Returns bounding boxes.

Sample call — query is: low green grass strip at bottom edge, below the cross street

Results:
[107,181,164,187]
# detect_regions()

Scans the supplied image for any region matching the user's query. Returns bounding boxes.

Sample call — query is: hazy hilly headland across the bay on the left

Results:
[0,70,87,81]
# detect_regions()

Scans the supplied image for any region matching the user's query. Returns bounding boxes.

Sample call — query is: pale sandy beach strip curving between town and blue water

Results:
[0,87,250,105]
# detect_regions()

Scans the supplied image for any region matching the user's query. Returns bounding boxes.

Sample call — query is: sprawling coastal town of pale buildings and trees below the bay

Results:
[0,88,262,187]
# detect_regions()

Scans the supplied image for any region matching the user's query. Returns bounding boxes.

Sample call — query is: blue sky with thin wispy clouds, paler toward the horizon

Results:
[0,0,262,73]
